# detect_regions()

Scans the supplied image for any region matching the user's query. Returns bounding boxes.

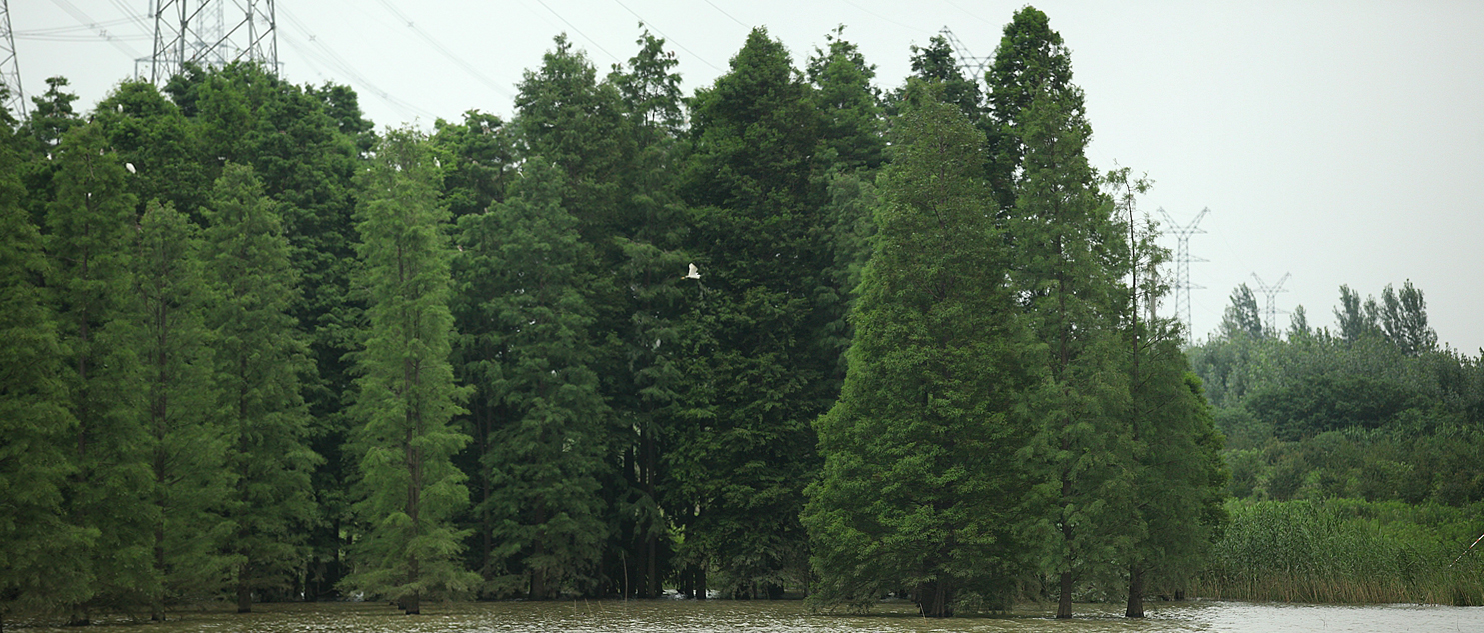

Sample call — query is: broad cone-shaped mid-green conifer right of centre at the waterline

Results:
[804,93,1036,617]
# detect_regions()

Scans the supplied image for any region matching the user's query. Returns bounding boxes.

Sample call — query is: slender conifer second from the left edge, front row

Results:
[45,125,159,623]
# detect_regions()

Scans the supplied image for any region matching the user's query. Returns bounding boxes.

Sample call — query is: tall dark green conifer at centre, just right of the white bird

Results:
[666,28,838,597]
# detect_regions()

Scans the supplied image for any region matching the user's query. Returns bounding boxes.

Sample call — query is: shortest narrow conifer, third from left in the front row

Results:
[128,200,236,620]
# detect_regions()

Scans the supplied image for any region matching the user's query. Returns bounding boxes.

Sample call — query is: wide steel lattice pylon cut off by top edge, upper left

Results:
[141,0,278,84]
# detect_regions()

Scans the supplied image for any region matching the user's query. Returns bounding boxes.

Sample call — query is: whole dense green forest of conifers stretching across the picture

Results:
[0,7,1484,624]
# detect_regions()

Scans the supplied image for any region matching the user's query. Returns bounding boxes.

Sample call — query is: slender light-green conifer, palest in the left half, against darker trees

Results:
[341,129,478,614]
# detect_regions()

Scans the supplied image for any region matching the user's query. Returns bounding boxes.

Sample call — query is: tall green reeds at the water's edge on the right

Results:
[1193,500,1484,605]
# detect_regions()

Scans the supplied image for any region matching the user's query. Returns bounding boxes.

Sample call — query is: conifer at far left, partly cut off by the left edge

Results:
[0,99,96,618]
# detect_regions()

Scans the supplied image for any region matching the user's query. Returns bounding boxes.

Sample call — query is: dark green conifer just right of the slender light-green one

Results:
[459,157,608,600]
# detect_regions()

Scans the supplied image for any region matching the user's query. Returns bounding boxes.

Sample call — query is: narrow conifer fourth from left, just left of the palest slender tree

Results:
[203,163,319,612]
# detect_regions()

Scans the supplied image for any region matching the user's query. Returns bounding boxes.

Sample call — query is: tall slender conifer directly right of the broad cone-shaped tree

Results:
[990,7,1132,618]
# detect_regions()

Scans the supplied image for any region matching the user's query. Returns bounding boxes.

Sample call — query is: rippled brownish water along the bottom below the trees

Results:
[20,600,1484,633]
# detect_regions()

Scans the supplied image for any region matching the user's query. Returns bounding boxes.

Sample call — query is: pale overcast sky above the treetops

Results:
[10,0,1484,356]
